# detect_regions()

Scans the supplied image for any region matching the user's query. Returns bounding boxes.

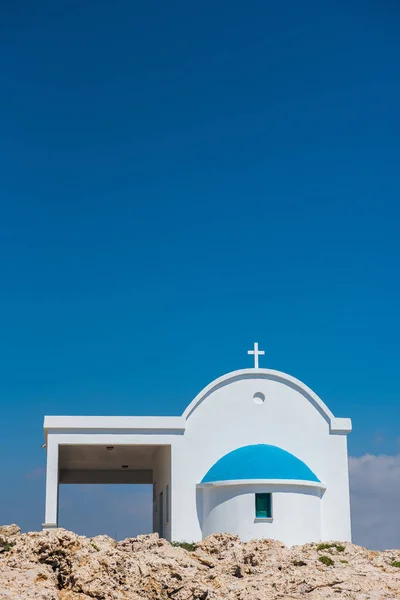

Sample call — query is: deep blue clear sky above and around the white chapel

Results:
[0,0,400,543]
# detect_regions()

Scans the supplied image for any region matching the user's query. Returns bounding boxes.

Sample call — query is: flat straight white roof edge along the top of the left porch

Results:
[44,416,186,430]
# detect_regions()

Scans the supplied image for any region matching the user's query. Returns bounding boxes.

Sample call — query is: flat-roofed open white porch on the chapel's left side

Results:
[43,417,184,539]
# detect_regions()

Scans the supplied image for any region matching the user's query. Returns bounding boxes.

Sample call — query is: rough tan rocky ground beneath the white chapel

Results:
[0,525,400,600]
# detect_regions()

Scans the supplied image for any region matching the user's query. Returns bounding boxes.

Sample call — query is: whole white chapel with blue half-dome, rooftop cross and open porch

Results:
[43,343,351,545]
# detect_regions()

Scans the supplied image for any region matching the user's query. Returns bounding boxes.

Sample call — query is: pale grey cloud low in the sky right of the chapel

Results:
[349,454,400,549]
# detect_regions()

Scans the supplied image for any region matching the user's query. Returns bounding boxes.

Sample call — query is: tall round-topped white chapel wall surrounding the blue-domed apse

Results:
[172,371,351,542]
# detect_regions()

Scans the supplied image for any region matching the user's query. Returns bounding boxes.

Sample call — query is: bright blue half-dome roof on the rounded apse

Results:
[201,444,320,483]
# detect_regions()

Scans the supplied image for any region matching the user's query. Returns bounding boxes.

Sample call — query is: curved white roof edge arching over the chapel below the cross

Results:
[182,368,351,433]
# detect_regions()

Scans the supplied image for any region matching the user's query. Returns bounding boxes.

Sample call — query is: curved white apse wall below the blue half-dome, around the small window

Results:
[201,485,321,545]
